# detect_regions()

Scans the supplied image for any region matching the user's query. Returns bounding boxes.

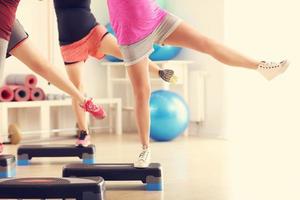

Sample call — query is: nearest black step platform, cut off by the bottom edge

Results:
[0,177,105,200]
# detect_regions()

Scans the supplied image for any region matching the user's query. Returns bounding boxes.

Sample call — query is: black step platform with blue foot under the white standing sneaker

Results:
[63,163,163,191]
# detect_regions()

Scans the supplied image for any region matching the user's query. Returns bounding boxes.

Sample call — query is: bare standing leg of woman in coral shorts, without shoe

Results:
[66,62,88,131]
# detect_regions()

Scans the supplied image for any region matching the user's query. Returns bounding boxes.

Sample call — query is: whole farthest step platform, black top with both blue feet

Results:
[18,145,96,166]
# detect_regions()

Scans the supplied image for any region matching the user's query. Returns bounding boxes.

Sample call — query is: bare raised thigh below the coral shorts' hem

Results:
[98,33,122,58]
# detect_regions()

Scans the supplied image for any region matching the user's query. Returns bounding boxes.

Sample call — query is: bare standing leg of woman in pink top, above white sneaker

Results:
[127,59,151,148]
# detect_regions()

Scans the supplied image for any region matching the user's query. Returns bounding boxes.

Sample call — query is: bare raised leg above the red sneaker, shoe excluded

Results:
[10,39,85,104]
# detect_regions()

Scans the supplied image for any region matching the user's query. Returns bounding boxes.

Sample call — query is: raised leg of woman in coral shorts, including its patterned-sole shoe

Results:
[99,34,177,82]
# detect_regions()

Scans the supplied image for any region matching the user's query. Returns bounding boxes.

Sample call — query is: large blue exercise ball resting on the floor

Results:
[150,90,190,141]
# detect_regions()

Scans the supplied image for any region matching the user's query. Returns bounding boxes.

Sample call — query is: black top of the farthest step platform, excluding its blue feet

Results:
[18,145,96,159]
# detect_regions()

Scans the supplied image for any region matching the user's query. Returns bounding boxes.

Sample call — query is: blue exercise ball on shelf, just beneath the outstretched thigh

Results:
[150,44,181,61]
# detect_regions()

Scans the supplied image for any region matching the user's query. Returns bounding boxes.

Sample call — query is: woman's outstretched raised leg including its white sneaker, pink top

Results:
[164,22,289,80]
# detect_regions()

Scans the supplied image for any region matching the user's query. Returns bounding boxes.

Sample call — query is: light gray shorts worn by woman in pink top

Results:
[120,13,182,66]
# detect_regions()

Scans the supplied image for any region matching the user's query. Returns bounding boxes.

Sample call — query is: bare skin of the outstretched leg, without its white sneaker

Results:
[164,22,260,69]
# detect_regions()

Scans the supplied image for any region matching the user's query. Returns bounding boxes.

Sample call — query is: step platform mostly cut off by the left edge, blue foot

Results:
[0,155,16,178]
